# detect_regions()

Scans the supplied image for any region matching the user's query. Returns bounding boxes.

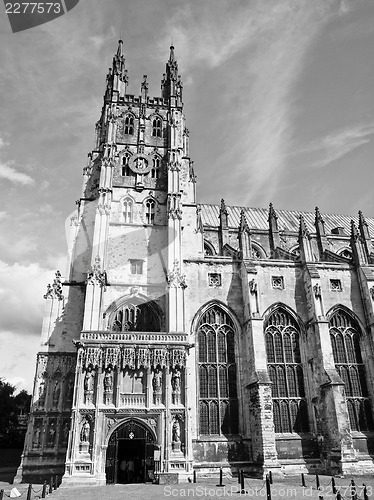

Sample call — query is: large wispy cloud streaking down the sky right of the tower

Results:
[157,0,344,203]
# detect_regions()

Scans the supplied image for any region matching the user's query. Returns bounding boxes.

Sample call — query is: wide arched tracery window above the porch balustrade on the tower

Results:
[109,302,160,332]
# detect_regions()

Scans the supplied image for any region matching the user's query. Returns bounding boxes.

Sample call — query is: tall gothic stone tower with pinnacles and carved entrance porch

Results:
[18,40,202,484]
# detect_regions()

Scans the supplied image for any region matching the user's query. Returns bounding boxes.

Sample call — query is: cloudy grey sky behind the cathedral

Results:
[0,0,374,391]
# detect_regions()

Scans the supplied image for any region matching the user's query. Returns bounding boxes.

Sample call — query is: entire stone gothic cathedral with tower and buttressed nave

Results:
[16,41,374,484]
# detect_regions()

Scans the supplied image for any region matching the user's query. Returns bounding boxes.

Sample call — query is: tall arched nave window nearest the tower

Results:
[196,306,238,435]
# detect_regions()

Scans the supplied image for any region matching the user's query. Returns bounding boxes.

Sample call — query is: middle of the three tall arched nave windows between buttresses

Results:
[265,308,309,432]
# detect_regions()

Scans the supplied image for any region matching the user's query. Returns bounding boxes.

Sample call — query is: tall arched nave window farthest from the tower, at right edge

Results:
[329,309,374,431]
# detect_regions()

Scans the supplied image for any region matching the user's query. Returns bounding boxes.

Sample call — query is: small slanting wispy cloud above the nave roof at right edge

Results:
[293,124,374,168]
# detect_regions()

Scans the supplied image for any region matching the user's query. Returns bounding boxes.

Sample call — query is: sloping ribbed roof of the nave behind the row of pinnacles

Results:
[199,204,374,237]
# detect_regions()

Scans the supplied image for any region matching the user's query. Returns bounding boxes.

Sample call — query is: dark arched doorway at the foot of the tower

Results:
[105,419,158,484]
